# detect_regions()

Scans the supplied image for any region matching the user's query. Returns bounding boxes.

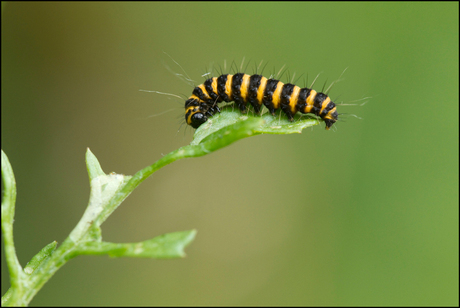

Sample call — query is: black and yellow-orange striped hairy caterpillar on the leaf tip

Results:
[185,73,338,130]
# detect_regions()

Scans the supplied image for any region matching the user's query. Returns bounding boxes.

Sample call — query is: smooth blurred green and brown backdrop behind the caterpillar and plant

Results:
[2,2,459,306]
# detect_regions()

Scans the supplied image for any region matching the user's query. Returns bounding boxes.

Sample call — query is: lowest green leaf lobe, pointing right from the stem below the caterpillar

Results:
[78,230,196,259]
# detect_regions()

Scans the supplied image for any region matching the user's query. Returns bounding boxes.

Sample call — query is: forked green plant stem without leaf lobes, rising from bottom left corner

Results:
[2,145,201,306]
